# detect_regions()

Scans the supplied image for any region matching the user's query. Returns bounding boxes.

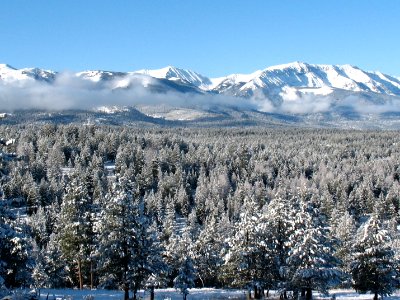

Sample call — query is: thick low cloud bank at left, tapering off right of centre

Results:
[0,73,256,112]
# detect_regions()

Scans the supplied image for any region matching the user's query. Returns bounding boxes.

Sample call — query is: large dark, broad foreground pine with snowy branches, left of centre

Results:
[97,177,166,299]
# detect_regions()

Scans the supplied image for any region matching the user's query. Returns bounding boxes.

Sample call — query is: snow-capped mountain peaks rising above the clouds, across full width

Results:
[0,62,400,97]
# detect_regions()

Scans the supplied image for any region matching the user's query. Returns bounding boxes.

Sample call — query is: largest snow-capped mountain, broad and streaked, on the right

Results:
[209,62,400,97]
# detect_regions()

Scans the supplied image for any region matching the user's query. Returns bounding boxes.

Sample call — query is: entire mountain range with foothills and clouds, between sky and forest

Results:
[0,62,400,128]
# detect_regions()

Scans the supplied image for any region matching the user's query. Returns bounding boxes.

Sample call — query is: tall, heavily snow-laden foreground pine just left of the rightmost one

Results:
[286,188,341,300]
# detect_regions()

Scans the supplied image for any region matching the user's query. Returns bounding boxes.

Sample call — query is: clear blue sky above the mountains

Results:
[0,0,400,77]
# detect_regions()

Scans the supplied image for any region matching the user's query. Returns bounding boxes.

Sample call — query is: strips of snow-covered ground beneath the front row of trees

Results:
[16,288,400,300]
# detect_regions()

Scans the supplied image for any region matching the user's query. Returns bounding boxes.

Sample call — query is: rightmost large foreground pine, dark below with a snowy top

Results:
[350,211,398,300]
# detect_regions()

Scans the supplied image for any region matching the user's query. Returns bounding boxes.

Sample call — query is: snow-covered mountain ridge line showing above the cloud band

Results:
[0,61,400,95]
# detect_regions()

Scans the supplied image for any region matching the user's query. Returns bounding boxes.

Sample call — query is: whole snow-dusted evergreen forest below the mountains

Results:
[0,125,400,299]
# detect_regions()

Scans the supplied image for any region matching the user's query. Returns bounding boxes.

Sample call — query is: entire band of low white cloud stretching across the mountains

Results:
[0,73,400,114]
